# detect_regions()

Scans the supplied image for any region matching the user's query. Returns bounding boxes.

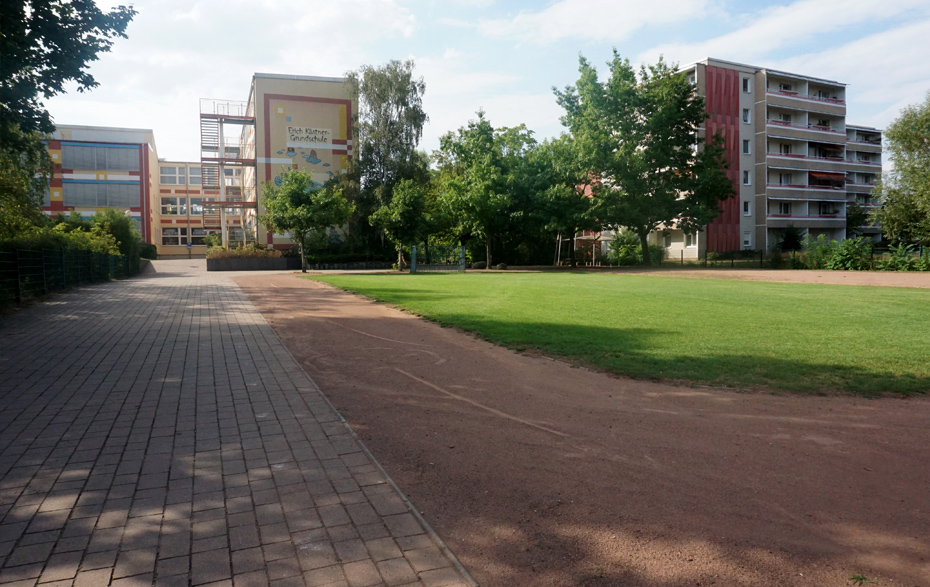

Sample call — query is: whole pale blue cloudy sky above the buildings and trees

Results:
[46,0,930,161]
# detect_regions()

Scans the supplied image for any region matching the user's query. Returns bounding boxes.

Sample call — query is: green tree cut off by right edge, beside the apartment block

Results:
[872,92,930,245]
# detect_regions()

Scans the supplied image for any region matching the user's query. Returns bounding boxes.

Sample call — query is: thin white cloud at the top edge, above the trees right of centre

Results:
[478,0,711,43]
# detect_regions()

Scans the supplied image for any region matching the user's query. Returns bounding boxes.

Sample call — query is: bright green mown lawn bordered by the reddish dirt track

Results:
[313,273,930,396]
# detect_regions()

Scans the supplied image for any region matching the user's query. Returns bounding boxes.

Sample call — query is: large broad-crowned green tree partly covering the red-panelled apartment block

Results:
[555,50,735,264]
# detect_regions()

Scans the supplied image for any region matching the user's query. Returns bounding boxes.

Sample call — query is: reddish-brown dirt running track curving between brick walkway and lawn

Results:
[236,275,930,587]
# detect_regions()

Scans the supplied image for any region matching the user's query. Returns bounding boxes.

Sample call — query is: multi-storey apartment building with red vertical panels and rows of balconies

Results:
[676,58,882,257]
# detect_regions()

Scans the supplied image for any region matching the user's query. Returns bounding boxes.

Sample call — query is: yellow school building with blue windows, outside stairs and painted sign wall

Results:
[44,73,357,256]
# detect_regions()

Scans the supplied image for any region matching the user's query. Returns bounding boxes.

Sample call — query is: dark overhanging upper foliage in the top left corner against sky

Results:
[0,0,136,149]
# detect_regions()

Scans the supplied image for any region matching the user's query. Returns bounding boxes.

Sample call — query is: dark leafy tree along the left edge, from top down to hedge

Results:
[0,0,136,239]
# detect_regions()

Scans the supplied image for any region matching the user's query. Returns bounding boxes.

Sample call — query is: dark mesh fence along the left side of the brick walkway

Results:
[0,249,139,308]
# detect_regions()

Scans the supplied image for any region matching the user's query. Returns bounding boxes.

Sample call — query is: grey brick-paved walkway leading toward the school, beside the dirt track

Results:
[0,260,471,587]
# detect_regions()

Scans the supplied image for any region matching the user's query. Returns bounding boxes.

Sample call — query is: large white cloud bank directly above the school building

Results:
[48,0,417,159]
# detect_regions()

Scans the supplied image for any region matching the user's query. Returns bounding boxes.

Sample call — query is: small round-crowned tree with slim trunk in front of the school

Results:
[258,170,355,272]
